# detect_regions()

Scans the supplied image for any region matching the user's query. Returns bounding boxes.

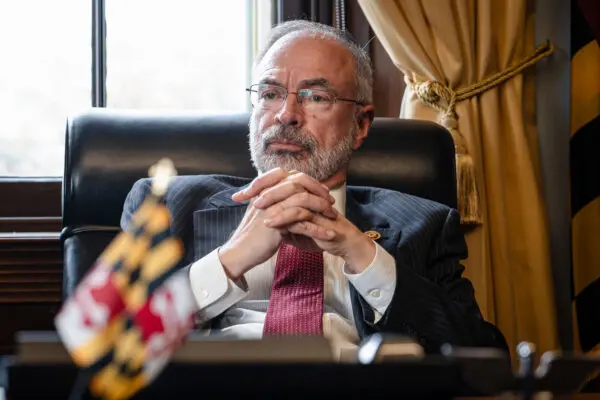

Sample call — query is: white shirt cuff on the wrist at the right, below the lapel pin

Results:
[342,242,396,323]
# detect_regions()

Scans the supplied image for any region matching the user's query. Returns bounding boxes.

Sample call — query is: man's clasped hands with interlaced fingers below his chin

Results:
[219,168,376,280]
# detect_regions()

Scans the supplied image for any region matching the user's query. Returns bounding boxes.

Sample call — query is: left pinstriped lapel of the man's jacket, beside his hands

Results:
[194,187,248,260]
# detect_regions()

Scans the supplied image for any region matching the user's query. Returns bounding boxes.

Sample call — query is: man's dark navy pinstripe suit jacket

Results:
[121,175,507,352]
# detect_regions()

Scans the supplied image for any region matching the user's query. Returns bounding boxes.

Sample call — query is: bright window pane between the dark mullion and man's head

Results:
[106,0,252,112]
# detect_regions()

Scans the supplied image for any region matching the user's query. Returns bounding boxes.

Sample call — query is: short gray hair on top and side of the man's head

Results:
[254,20,373,104]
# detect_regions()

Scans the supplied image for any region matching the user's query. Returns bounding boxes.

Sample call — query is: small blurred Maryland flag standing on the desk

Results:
[55,159,196,399]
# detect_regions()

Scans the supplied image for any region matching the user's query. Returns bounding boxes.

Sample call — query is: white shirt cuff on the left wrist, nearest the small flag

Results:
[190,248,248,323]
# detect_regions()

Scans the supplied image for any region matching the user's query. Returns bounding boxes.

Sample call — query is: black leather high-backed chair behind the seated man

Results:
[62,109,456,296]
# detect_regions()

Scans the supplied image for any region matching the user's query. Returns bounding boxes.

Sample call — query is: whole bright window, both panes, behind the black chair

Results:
[0,0,271,178]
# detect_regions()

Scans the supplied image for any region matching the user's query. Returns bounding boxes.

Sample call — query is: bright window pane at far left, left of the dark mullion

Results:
[0,0,91,177]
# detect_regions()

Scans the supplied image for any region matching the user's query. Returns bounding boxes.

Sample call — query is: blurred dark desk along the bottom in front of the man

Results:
[0,338,600,400]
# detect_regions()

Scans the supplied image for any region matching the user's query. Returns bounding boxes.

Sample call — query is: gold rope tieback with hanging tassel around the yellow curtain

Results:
[404,42,554,225]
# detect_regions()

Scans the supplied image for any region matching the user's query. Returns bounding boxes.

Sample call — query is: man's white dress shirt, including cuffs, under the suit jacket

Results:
[190,185,396,357]
